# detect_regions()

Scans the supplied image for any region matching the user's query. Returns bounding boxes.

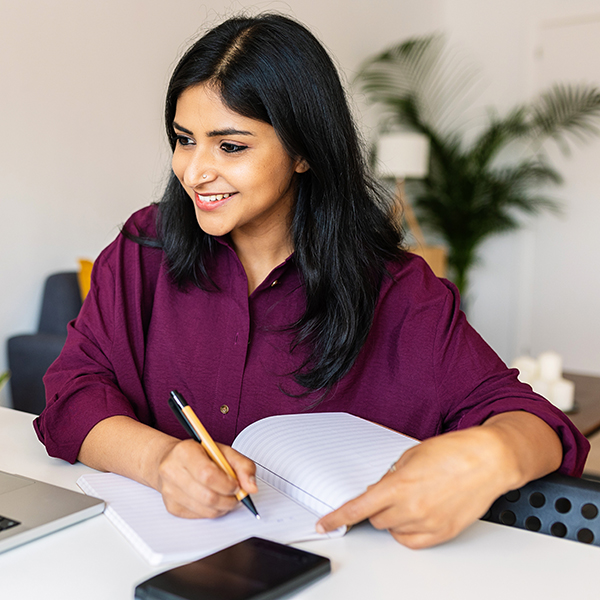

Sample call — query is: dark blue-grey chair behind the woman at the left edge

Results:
[8,271,81,414]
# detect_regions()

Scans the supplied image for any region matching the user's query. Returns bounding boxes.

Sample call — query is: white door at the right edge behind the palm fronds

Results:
[530,12,600,372]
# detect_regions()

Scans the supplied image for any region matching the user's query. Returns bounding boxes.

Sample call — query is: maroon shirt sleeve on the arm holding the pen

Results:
[34,209,162,463]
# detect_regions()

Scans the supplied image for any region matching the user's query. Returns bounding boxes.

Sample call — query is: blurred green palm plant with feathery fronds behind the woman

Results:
[356,35,600,297]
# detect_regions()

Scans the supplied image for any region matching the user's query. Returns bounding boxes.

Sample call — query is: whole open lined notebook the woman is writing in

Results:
[77,413,418,565]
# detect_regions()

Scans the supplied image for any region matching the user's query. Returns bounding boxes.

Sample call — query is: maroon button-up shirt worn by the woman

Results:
[35,207,589,474]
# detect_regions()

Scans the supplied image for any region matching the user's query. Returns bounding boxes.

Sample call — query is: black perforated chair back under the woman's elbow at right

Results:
[483,473,600,546]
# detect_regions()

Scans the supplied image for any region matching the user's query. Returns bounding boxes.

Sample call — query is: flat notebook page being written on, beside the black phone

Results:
[77,473,344,565]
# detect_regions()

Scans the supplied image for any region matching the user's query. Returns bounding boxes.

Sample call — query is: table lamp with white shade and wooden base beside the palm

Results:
[377,131,446,277]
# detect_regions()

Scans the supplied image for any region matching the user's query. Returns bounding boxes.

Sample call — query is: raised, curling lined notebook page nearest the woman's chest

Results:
[233,413,419,515]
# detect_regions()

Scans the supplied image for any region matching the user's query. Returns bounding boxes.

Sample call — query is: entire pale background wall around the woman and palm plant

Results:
[0,0,600,405]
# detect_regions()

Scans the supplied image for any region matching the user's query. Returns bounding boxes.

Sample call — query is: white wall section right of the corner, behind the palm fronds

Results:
[444,0,600,374]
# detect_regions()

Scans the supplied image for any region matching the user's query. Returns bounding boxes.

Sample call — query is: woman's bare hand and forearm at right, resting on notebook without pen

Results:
[317,412,562,548]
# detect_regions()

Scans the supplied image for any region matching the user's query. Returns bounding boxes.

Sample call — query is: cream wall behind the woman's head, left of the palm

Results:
[0,0,441,402]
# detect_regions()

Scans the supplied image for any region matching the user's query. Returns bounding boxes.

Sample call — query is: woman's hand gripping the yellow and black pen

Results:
[157,440,258,519]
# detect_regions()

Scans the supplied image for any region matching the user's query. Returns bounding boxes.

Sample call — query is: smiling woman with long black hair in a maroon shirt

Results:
[35,15,587,548]
